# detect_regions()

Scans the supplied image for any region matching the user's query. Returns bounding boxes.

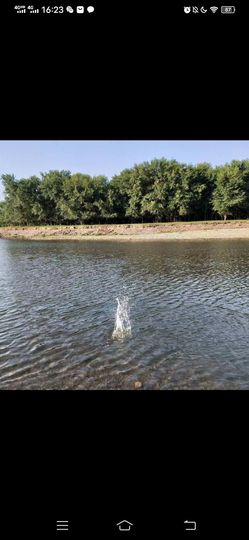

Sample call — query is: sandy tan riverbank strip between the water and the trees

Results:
[0,221,249,241]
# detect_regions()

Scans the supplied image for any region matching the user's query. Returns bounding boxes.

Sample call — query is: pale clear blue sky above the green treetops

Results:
[0,141,249,199]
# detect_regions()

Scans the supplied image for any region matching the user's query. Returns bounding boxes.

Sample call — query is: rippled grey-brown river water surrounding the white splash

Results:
[0,240,249,389]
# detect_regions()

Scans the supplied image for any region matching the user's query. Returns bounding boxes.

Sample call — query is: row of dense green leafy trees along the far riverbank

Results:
[0,158,249,226]
